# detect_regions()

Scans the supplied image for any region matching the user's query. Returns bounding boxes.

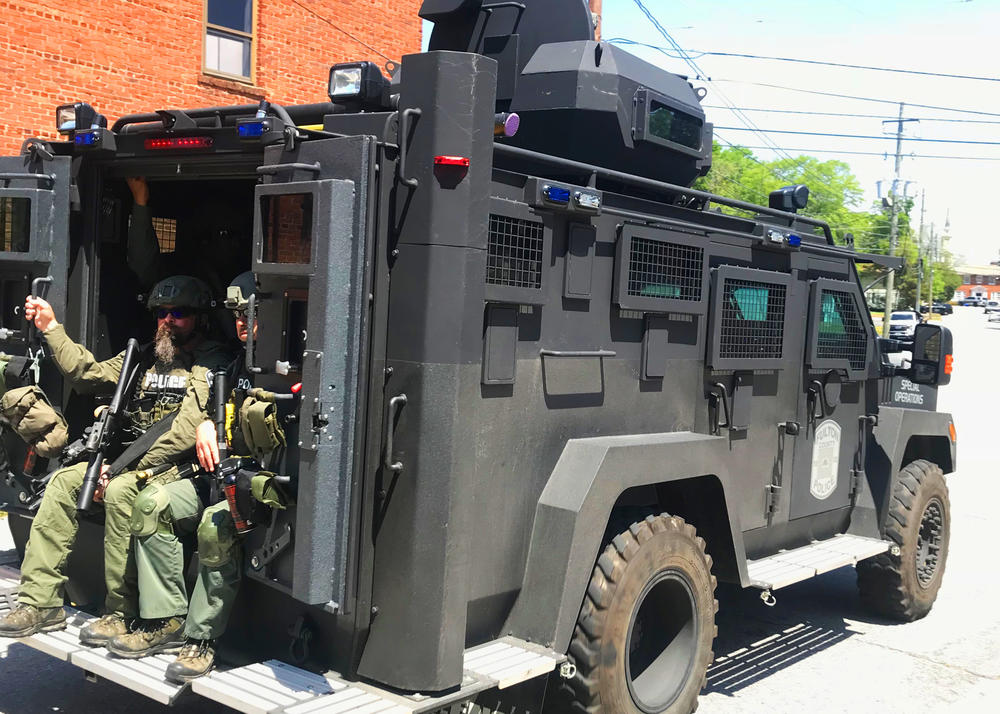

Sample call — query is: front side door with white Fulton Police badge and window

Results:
[789,272,874,519]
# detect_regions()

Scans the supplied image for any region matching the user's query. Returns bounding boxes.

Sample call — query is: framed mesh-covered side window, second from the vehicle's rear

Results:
[615,225,707,313]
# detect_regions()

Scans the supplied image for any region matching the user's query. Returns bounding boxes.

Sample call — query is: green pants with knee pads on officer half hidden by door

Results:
[132,480,242,640]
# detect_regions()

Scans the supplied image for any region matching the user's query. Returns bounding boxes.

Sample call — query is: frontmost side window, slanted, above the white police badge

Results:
[806,278,870,378]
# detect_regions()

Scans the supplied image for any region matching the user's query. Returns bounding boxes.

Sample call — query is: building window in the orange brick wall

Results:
[204,0,256,82]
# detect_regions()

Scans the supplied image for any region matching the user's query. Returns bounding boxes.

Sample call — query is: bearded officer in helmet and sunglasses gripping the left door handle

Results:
[0,275,229,645]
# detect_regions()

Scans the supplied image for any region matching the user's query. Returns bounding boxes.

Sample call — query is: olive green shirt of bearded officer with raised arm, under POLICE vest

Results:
[44,324,230,469]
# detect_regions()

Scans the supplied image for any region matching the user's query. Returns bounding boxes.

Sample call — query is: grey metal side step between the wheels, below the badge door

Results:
[747,534,891,590]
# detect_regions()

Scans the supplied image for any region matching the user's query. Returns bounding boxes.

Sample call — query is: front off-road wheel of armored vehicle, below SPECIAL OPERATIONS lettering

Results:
[857,459,951,622]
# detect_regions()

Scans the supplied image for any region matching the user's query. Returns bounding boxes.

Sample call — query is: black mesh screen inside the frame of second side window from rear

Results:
[628,238,704,301]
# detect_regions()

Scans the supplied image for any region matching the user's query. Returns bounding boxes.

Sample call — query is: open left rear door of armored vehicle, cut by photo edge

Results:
[0,149,70,503]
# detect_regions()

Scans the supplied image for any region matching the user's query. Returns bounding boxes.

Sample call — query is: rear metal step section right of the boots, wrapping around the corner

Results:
[191,637,565,714]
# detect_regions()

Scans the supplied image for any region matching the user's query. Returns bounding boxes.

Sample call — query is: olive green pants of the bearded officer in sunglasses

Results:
[18,463,156,618]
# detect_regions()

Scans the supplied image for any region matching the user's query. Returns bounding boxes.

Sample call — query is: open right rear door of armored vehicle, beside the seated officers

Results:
[248,136,376,612]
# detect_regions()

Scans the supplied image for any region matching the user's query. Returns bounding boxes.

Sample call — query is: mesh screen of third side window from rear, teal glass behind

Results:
[719,278,785,359]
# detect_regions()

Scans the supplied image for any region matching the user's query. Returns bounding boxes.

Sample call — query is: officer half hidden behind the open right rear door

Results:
[108,272,288,682]
